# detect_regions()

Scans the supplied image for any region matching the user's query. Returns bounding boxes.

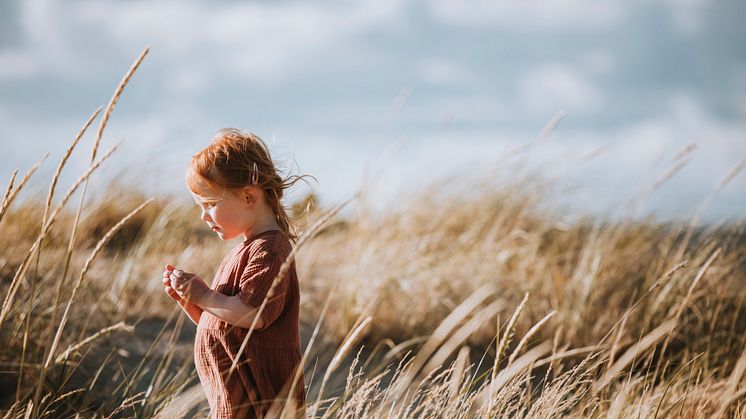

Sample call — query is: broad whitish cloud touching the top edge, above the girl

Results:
[71,0,401,82]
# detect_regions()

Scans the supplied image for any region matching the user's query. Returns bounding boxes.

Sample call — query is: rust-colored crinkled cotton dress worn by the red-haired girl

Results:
[194,230,305,418]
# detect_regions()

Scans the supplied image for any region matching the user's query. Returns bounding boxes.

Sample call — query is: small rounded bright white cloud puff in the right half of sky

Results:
[520,63,603,115]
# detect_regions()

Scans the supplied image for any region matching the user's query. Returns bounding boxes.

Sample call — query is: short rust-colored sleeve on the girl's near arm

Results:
[237,251,290,329]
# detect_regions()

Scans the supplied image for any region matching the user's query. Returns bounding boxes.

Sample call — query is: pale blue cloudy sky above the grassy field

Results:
[0,0,746,220]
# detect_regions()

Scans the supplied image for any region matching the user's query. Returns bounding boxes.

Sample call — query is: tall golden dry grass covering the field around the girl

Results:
[0,48,746,418]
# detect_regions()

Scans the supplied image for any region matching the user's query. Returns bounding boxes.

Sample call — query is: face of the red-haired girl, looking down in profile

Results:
[192,190,254,240]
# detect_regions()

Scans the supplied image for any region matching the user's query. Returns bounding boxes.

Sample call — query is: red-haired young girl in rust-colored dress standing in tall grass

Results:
[163,129,305,418]
